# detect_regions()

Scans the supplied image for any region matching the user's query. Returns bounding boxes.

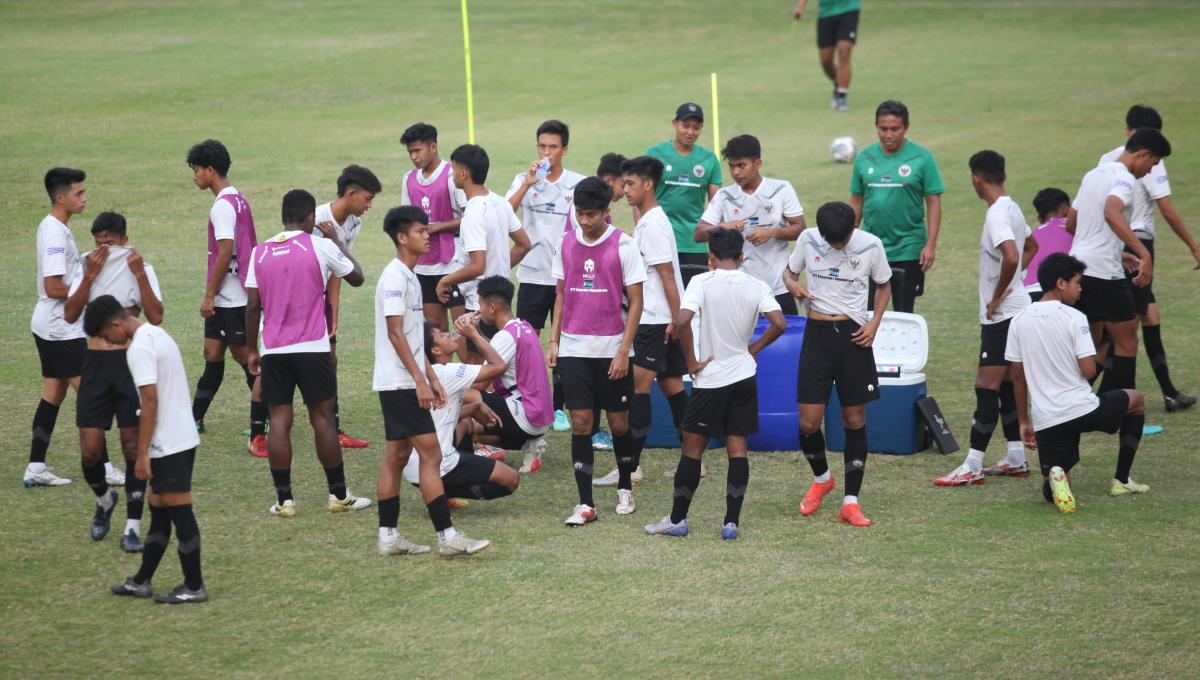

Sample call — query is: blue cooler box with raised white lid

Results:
[824,312,929,455]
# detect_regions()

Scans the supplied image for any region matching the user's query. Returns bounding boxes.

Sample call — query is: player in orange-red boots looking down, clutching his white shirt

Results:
[784,203,892,526]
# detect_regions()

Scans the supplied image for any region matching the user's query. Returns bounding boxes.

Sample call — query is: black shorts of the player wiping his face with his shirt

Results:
[76,349,142,429]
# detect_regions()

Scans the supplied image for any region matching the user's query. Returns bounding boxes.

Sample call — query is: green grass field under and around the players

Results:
[0,0,1200,678]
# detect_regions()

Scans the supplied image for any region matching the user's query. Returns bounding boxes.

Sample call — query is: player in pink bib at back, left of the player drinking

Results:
[400,122,467,331]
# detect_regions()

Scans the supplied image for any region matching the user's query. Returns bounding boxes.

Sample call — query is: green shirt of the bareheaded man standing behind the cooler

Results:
[850,140,946,261]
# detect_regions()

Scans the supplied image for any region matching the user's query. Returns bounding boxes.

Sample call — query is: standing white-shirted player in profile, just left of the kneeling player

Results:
[934,151,1038,487]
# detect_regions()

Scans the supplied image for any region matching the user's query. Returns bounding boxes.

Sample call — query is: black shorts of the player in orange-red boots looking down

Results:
[796,319,880,407]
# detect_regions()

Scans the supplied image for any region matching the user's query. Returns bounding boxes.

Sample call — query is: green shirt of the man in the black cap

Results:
[646,140,721,253]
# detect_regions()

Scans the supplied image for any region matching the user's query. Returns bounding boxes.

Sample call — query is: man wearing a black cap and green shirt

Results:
[646,102,721,288]
